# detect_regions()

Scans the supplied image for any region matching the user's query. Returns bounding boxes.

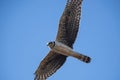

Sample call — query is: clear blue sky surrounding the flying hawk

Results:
[0,0,120,80]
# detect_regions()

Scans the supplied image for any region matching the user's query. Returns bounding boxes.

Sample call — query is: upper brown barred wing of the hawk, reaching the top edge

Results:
[56,0,82,48]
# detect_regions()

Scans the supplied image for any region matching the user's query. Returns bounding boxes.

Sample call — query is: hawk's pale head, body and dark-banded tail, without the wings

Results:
[48,41,90,63]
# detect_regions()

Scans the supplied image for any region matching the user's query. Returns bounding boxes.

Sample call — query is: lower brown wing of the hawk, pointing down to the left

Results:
[34,51,66,80]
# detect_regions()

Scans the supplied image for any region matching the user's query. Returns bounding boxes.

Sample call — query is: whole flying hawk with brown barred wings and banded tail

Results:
[34,0,91,80]
